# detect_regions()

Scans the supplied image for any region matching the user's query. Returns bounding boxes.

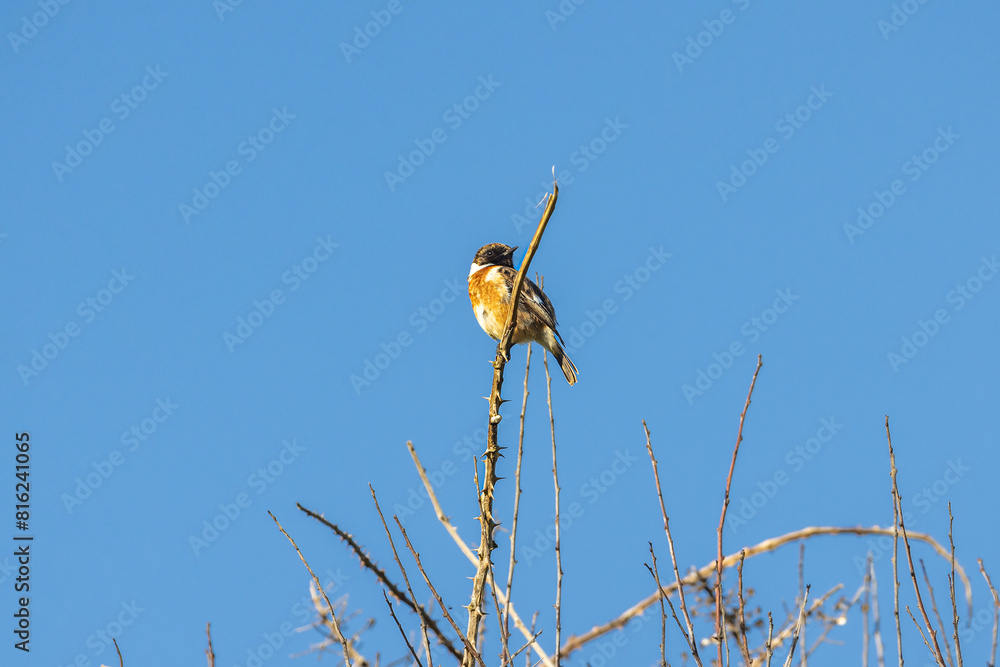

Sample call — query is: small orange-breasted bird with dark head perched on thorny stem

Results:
[469,243,577,385]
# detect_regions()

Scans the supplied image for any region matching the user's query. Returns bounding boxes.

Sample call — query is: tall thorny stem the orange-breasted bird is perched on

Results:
[462,175,559,667]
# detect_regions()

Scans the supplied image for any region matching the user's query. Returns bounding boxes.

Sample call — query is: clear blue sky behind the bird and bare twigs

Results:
[0,0,1000,666]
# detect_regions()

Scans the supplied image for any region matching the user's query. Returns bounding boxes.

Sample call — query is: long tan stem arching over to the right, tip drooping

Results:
[562,526,972,659]
